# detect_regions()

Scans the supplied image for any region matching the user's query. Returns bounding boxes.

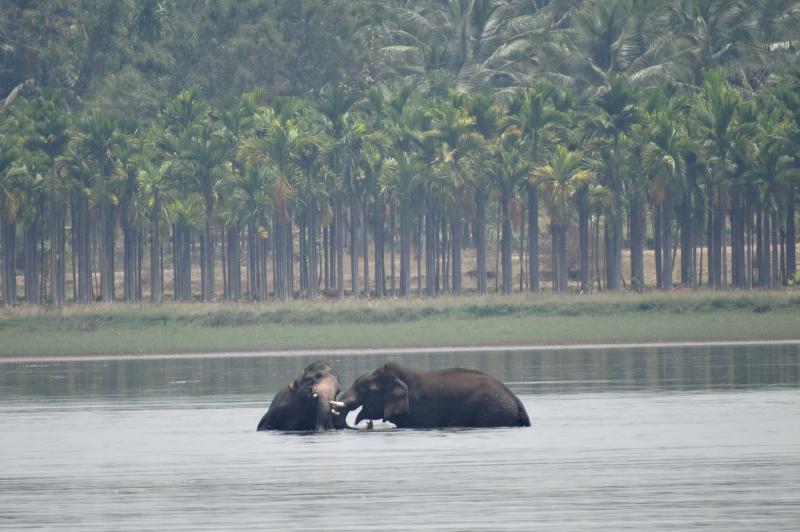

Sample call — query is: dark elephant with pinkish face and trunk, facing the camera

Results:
[257,362,347,431]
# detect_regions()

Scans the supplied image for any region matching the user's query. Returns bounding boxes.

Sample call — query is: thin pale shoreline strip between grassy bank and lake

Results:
[0,339,800,365]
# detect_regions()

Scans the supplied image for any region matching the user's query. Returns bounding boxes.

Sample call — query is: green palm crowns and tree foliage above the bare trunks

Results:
[0,0,800,306]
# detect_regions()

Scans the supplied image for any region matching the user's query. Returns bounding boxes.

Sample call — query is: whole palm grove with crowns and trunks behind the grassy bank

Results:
[0,0,800,305]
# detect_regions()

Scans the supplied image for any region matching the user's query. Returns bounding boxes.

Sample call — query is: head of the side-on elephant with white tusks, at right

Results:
[330,363,409,424]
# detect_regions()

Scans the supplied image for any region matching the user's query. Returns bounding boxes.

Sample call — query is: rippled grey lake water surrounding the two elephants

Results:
[0,346,800,531]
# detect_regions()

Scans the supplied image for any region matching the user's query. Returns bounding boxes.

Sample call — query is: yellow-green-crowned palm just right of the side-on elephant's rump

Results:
[534,145,594,292]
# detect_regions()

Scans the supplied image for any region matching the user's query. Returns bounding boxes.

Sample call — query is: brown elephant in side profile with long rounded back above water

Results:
[330,362,531,428]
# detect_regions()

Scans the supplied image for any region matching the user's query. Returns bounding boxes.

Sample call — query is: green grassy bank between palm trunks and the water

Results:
[0,291,800,356]
